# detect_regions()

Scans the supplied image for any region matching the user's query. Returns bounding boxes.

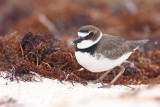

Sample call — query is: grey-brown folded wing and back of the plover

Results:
[97,34,148,59]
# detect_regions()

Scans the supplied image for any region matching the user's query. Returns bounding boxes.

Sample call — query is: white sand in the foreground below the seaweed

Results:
[0,74,160,107]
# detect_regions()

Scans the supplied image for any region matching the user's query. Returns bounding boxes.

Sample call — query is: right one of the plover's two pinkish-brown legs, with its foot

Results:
[100,65,125,88]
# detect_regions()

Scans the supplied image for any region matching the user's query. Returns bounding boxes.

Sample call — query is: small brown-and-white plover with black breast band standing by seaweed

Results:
[73,25,148,88]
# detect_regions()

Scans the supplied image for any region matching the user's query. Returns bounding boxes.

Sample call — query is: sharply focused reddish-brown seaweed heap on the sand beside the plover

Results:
[0,32,160,85]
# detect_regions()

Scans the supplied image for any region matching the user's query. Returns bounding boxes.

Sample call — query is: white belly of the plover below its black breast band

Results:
[75,51,132,72]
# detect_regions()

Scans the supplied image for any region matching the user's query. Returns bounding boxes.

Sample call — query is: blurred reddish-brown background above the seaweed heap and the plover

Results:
[0,0,160,50]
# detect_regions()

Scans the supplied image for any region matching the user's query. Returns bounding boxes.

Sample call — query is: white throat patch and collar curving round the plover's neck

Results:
[77,32,102,49]
